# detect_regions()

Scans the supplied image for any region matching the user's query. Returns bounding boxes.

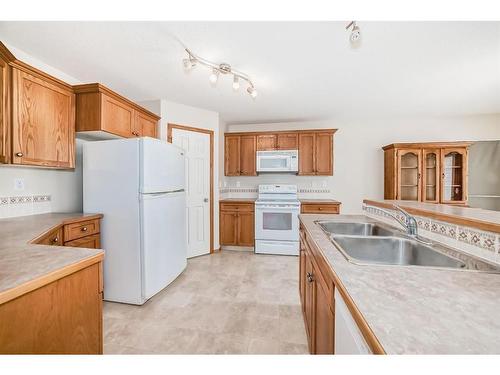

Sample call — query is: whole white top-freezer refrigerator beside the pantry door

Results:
[83,137,187,305]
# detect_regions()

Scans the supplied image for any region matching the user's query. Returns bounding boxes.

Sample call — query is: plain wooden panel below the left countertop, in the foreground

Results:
[0,262,103,354]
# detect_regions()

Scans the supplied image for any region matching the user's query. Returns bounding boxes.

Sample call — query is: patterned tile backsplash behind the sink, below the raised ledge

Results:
[363,204,500,264]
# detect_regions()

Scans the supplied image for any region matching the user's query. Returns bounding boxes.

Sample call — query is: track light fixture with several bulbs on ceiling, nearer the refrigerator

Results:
[182,48,257,99]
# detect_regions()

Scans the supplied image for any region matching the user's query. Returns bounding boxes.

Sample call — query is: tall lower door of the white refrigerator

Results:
[141,192,187,300]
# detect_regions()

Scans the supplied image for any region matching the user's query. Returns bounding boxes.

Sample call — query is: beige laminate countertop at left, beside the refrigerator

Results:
[0,213,104,304]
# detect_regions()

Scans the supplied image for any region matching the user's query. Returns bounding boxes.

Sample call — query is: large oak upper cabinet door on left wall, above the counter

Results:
[12,69,75,168]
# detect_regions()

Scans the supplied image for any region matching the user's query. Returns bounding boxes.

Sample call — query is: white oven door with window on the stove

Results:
[255,206,299,241]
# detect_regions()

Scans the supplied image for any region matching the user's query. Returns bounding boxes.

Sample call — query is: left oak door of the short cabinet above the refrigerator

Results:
[101,94,136,138]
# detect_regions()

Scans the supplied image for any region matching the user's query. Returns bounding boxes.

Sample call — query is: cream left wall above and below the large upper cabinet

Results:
[0,45,82,213]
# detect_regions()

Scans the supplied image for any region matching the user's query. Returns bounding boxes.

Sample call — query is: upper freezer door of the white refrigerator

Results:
[140,137,186,194]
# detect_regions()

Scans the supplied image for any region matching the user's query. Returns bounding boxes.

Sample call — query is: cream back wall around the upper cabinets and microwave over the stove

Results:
[221,114,500,213]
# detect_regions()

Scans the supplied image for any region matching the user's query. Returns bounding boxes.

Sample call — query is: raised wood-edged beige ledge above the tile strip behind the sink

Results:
[363,199,500,233]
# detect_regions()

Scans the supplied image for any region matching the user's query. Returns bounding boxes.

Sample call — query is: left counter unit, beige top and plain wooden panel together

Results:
[0,213,104,354]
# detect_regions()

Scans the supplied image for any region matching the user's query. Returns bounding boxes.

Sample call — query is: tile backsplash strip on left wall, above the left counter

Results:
[0,195,52,219]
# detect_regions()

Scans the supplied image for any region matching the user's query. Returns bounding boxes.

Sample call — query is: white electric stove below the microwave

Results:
[255,185,300,255]
